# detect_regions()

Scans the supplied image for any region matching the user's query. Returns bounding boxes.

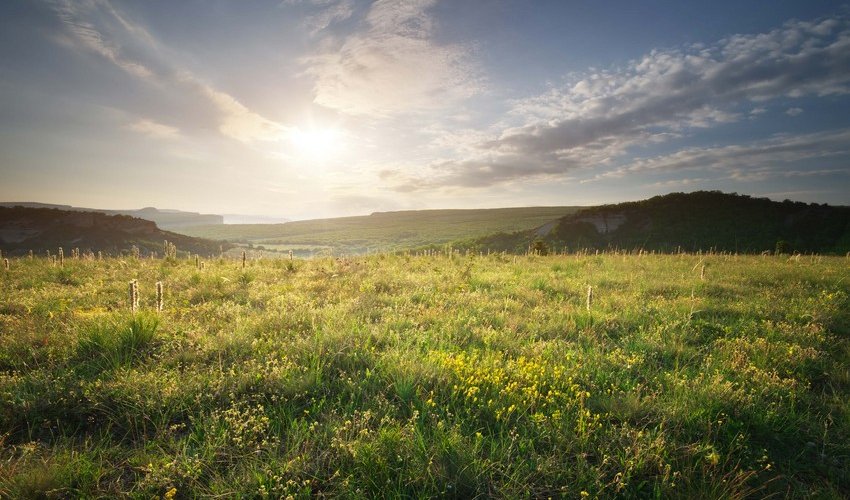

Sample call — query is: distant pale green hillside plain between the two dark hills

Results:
[175,207,581,255]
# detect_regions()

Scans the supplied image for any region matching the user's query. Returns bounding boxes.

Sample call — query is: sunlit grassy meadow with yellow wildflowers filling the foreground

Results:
[0,255,850,498]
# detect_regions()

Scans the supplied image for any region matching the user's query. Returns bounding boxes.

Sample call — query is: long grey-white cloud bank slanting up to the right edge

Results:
[396,13,850,189]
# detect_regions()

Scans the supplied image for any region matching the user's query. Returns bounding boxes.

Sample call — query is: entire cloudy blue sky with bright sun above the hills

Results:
[0,0,850,219]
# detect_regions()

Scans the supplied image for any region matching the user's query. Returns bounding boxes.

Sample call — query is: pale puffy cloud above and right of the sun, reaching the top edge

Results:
[303,0,480,116]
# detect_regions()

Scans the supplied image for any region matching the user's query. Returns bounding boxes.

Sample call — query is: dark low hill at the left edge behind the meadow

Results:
[0,207,230,255]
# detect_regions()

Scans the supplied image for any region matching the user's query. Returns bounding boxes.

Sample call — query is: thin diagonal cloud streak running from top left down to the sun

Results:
[53,0,287,143]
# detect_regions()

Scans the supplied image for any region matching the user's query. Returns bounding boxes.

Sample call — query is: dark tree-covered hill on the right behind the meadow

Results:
[468,191,850,254]
